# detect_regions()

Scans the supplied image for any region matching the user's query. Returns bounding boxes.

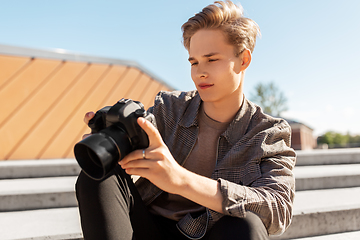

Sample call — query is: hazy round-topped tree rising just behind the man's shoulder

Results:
[250,82,288,116]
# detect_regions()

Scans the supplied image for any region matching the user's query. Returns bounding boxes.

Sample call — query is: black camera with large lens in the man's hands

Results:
[74,98,156,180]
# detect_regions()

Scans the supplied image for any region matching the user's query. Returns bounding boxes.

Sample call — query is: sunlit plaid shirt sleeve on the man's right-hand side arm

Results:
[218,121,296,235]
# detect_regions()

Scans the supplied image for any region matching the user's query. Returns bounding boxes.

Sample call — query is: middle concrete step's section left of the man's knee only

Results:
[0,176,77,211]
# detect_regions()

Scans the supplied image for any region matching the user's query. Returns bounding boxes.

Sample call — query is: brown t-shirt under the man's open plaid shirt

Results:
[149,106,230,221]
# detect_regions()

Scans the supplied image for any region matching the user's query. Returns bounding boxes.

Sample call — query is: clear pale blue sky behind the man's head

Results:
[0,0,360,135]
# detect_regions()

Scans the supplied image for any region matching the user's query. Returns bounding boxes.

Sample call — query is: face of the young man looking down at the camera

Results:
[189,29,242,104]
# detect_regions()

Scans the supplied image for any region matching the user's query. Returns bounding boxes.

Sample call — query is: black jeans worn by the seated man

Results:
[76,166,268,240]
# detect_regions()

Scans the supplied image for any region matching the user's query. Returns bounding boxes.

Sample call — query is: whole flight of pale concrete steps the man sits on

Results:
[0,156,360,240]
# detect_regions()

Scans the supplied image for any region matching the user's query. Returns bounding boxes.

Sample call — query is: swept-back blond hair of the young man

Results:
[181,1,260,56]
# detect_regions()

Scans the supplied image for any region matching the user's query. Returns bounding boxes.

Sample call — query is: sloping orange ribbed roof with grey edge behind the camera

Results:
[0,45,172,160]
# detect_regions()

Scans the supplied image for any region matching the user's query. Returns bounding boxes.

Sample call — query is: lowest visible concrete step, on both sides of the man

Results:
[0,187,360,239]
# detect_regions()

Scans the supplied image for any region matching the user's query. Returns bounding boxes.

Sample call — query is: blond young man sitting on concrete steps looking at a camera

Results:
[77,1,295,240]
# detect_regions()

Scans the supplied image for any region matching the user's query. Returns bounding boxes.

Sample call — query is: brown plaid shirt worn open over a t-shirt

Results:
[136,91,296,238]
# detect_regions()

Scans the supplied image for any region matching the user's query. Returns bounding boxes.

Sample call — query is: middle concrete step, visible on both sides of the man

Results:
[0,164,360,211]
